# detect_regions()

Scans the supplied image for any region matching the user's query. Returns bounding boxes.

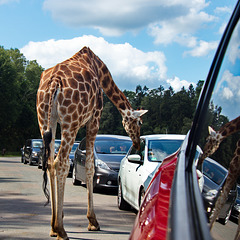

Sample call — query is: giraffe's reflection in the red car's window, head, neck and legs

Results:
[199,116,240,239]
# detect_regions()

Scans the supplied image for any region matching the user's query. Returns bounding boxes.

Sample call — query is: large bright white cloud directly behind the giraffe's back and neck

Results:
[20,36,167,90]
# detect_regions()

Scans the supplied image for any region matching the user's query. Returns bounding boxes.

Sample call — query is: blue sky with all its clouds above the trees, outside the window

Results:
[0,0,236,101]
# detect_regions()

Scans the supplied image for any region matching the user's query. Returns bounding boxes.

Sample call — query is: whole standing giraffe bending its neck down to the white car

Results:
[36,47,147,240]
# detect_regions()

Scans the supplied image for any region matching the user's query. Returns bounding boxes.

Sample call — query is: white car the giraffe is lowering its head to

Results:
[118,134,185,210]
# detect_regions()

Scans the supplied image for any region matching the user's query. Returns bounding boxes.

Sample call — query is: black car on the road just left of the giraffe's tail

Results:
[23,139,43,165]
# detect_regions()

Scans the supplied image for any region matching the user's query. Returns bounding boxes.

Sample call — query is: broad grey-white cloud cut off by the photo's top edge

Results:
[43,0,189,35]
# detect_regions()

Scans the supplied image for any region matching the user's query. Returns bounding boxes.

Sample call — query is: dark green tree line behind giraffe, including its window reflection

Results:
[0,47,239,171]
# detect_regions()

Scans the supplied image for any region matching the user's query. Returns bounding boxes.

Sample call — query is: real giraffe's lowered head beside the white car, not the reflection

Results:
[122,110,148,149]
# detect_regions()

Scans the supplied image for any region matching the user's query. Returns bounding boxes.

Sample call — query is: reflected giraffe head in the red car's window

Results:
[201,126,222,160]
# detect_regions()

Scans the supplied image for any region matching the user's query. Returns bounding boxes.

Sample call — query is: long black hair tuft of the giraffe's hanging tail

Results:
[42,130,52,206]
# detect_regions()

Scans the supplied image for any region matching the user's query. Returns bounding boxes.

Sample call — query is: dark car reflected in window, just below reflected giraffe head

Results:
[202,158,237,224]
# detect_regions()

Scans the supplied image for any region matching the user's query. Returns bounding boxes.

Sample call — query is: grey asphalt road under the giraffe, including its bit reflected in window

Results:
[0,157,237,240]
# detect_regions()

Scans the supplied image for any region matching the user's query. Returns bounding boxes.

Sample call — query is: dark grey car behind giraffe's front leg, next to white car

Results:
[72,135,132,189]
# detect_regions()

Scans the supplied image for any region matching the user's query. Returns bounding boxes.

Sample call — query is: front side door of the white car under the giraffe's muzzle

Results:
[125,140,145,209]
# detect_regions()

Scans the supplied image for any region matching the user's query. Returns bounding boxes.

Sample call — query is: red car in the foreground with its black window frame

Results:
[130,1,240,240]
